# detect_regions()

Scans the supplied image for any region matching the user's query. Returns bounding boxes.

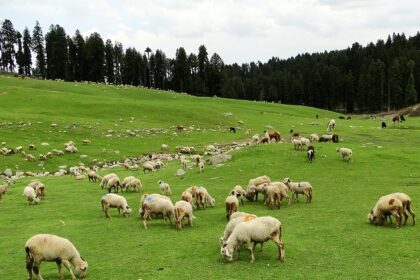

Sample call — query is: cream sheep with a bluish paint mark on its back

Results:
[139,195,175,229]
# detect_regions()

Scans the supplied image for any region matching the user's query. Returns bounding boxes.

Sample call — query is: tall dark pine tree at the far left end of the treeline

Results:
[0,19,17,72]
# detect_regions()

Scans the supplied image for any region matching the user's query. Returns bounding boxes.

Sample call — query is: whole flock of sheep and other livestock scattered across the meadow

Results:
[0,114,416,279]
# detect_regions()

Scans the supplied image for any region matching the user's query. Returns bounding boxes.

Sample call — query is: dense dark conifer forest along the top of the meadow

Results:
[0,19,420,113]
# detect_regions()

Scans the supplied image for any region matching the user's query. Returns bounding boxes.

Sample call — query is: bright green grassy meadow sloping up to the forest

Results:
[0,76,420,280]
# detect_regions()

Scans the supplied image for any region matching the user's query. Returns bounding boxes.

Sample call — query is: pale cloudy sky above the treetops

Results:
[0,0,420,63]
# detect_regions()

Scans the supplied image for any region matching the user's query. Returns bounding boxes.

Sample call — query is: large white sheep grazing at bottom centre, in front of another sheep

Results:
[220,216,286,263]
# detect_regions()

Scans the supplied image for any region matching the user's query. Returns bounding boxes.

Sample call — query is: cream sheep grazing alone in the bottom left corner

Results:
[25,234,88,280]
